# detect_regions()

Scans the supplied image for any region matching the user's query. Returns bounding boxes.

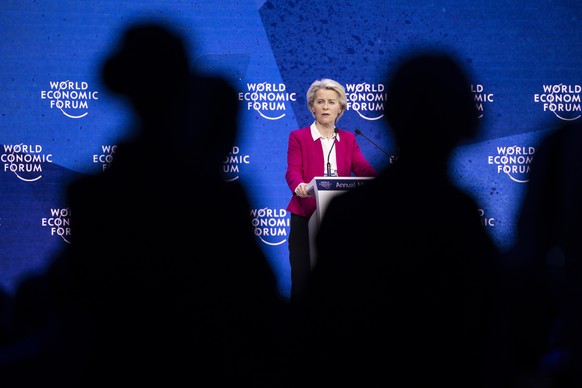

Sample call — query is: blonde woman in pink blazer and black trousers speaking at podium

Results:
[285,79,377,304]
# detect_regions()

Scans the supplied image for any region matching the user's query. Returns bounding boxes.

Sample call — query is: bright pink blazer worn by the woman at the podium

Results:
[285,126,378,217]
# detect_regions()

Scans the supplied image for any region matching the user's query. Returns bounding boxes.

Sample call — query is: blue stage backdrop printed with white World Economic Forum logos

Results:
[0,0,582,295]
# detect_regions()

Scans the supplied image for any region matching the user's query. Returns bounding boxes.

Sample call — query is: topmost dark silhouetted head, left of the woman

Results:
[102,23,190,110]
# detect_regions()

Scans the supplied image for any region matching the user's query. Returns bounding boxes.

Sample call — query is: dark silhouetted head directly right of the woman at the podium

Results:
[385,52,478,157]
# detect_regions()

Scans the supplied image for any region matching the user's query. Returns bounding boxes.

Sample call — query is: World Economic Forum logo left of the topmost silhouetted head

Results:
[40,80,99,119]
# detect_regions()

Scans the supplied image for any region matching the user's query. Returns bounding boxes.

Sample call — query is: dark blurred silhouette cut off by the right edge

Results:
[504,121,582,388]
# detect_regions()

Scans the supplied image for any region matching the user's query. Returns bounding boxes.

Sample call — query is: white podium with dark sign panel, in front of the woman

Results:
[307,176,374,268]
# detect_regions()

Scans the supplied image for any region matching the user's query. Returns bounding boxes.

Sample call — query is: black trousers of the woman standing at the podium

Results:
[288,213,311,303]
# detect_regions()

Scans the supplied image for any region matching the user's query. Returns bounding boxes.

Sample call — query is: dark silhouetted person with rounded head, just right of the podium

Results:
[305,49,497,388]
